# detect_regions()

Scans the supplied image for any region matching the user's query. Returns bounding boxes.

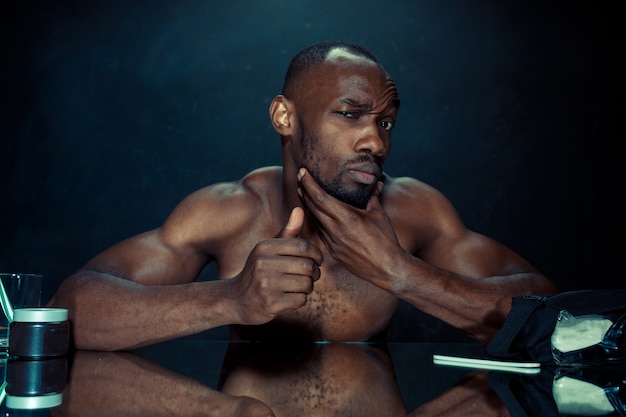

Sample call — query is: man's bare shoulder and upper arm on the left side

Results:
[77,183,255,285]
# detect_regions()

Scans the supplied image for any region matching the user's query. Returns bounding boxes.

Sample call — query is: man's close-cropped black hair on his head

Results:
[283,41,380,98]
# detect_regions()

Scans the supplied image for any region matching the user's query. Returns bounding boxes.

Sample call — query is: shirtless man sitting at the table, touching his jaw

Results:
[51,43,554,349]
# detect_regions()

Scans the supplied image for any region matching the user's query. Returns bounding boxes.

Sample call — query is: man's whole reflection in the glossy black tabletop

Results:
[52,342,508,417]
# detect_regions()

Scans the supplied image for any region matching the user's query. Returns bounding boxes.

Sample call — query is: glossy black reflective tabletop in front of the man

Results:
[1,337,626,417]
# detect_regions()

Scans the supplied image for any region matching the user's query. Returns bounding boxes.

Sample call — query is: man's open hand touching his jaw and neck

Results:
[298,168,405,290]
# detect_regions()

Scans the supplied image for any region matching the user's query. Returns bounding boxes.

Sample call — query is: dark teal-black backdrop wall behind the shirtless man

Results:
[0,0,626,306]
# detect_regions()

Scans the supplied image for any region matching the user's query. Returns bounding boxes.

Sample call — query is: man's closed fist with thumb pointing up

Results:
[233,207,323,324]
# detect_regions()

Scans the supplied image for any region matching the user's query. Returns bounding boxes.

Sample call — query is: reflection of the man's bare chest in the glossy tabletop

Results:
[220,343,407,417]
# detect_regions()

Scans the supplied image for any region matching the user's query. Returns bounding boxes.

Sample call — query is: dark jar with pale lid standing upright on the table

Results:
[9,308,70,359]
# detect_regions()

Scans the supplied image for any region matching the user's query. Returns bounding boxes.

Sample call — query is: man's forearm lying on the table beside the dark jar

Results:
[49,272,238,350]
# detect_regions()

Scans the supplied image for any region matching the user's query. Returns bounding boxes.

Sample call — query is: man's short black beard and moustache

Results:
[300,129,374,209]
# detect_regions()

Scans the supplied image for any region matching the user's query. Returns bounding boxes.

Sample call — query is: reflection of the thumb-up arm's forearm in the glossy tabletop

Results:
[51,351,274,417]
